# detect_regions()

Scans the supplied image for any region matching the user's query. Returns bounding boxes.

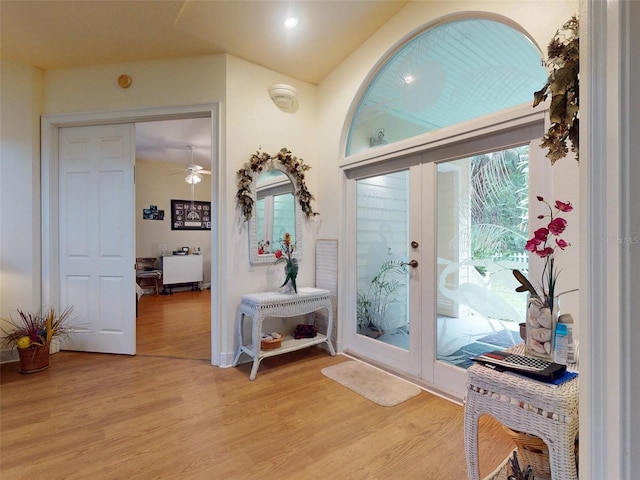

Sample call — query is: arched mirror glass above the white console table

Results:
[249,164,302,263]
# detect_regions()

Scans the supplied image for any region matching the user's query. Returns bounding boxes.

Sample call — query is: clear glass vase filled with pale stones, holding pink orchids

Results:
[525,296,560,362]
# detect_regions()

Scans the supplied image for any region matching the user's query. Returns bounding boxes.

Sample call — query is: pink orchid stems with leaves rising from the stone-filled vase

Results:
[513,196,573,310]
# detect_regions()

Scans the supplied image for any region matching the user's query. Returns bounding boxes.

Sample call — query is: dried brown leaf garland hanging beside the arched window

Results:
[533,16,580,165]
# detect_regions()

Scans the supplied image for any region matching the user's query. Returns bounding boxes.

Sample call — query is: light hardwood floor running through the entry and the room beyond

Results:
[0,292,513,480]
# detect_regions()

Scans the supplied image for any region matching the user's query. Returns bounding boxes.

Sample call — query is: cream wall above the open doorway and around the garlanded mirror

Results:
[44,55,320,365]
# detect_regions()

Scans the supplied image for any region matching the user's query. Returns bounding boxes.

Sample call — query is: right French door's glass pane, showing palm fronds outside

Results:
[435,146,529,368]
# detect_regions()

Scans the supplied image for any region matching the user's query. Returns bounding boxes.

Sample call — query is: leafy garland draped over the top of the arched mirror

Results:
[236,148,318,222]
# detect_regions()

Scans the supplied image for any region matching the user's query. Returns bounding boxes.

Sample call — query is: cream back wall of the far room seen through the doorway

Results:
[135,160,211,283]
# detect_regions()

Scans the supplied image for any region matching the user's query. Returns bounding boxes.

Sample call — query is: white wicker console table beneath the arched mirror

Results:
[233,288,336,380]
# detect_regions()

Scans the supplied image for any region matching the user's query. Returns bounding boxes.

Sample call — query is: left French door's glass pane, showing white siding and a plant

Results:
[356,171,409,350]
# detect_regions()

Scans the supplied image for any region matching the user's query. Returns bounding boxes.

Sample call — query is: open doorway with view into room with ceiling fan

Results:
[135,118,212,360]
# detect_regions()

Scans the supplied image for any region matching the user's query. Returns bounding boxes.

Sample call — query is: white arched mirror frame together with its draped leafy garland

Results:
[236,148,318,264]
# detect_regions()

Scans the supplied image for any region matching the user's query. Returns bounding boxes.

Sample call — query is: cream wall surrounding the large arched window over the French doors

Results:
[317,0,579,326]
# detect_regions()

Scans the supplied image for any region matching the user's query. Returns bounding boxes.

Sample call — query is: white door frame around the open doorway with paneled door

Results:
[41,103,226,365]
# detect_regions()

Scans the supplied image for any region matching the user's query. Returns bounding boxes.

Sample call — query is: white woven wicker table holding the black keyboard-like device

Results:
[464,344,579,480]
